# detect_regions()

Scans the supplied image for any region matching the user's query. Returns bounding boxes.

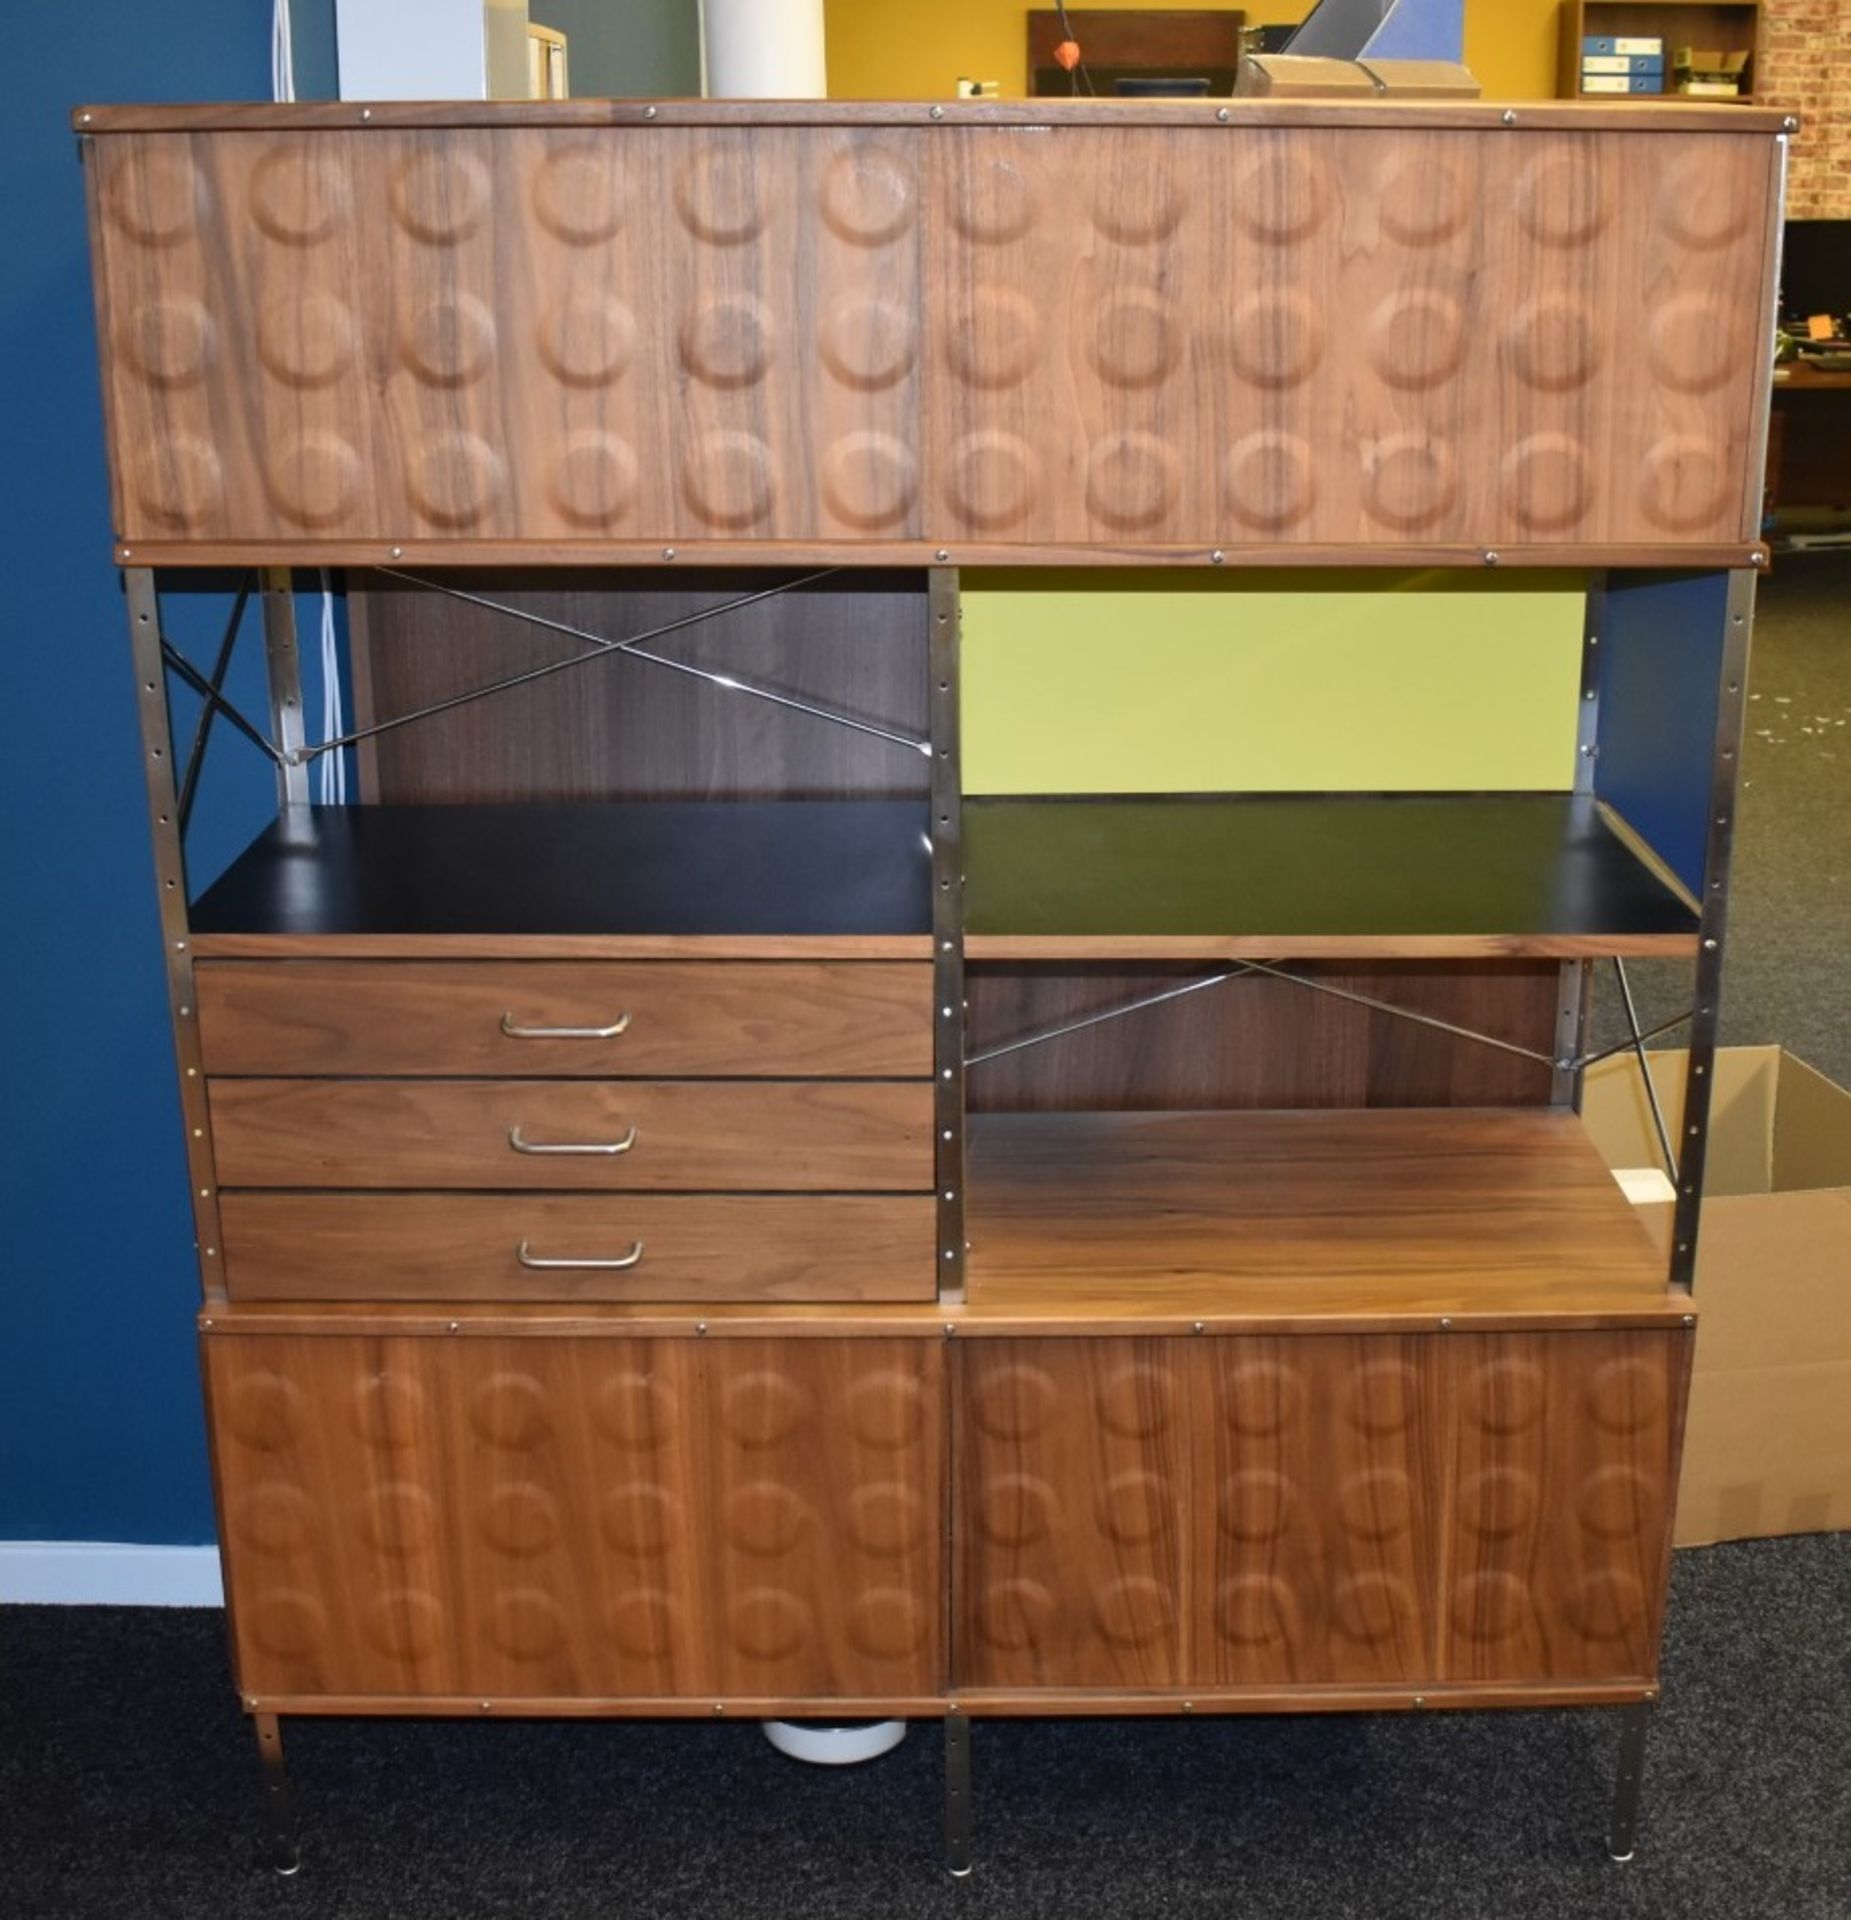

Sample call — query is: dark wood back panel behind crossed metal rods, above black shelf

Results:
[349,568,929,803]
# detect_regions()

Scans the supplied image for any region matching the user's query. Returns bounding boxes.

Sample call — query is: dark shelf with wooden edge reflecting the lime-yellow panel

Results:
[964,793,1697,960]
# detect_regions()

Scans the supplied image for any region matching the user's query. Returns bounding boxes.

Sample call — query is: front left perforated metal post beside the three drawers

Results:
[123,566,225,1302]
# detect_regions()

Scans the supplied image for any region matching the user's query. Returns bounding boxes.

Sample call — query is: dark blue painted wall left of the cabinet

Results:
[0,0,289,1542]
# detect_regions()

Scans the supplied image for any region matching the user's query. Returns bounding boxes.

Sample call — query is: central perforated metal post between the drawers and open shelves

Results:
[926,566,966,1302]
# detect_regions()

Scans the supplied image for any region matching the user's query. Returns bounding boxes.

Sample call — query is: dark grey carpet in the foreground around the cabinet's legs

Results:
[0,1534,1851,1920]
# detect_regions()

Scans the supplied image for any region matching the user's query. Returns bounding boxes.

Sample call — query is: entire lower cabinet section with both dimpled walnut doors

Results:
[205,1327,1692,1711]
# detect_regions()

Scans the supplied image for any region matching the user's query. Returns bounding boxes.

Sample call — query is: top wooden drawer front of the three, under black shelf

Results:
[198,960,931,1079]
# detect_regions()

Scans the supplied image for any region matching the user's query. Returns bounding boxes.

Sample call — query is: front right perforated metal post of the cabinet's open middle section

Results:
[1671,568,1755,1286]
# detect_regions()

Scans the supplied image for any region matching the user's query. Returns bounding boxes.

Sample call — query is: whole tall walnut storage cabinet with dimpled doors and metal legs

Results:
[77,102,1786,1868]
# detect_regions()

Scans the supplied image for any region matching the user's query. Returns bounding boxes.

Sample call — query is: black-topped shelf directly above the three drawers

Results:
[192,801,931,954]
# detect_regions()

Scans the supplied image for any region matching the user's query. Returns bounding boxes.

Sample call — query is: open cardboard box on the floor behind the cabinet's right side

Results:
[1582,1046,1851,1546]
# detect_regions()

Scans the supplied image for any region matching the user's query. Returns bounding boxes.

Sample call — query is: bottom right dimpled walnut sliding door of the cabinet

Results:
[952,1331,1690,1692]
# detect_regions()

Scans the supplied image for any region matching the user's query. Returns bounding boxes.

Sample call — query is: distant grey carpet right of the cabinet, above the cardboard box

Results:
[1596,551,1851,1087]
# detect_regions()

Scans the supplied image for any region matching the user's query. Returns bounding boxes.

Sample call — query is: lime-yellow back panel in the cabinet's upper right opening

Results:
[962,572,1584,793]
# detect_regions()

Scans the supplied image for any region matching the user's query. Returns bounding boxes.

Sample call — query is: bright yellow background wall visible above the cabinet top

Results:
[824,0,1557,100]
